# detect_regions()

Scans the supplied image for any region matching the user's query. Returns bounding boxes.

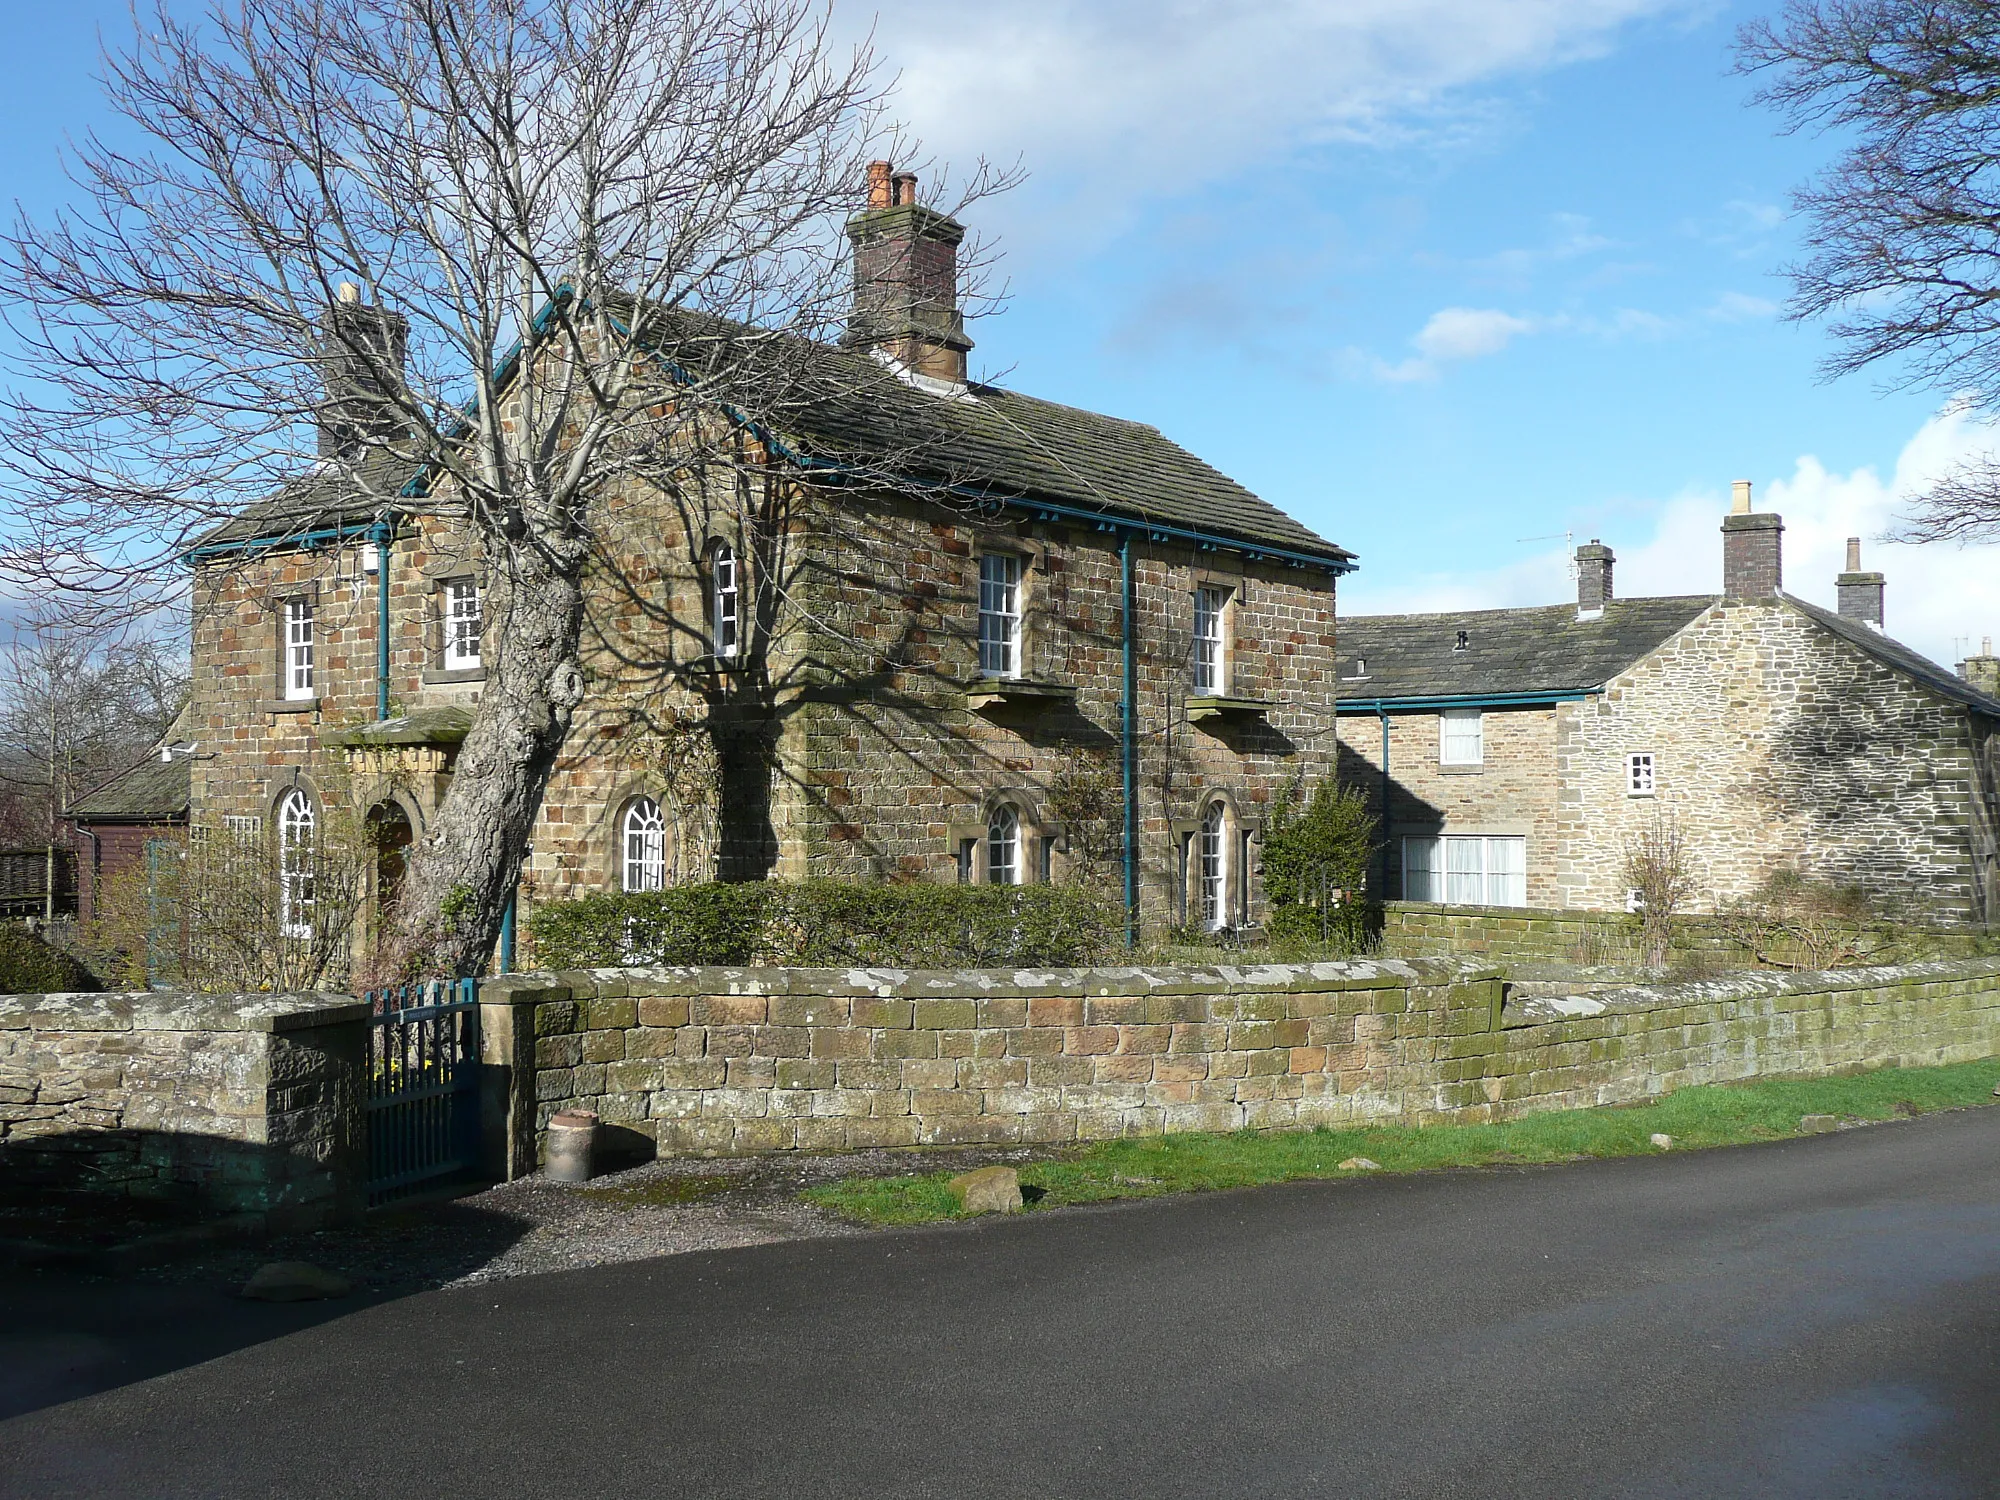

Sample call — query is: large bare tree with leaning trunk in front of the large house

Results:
[4,0,998,970]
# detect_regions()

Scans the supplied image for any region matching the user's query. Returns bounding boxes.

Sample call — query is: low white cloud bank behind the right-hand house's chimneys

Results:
[1340,406,2000,666]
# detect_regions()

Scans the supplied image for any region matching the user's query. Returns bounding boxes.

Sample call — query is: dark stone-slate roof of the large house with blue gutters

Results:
[200,314,1354,566]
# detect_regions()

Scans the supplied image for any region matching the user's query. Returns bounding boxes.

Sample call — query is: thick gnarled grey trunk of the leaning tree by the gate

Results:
[380,546,584,978]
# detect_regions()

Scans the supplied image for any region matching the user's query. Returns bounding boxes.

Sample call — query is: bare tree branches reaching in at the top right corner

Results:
[1738,0,2000,542]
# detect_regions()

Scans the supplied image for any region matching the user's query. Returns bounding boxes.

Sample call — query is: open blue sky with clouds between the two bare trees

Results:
[0,0,2000,660]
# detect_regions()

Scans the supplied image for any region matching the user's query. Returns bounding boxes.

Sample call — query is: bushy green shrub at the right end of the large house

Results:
[1264,776,1376,952]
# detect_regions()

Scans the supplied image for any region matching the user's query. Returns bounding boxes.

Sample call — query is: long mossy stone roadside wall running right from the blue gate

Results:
[482,960,2000,1174]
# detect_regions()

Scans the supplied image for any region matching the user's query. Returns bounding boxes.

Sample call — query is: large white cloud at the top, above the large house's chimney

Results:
[864,0,1702,253]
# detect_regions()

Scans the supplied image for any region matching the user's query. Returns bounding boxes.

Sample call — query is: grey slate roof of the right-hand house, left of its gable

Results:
[1336,594,1716,702]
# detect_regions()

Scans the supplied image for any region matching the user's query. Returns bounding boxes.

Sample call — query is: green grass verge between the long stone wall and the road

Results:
[800,1060,2000,1224]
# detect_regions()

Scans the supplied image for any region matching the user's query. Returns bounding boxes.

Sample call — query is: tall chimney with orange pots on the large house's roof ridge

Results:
[840,162,972,384]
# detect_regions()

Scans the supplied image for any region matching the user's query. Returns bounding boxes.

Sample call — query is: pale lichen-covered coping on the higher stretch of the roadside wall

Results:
[496,958,1500,1004]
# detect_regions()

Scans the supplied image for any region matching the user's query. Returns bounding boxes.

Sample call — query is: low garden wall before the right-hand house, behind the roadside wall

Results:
[1382,902,1978,964]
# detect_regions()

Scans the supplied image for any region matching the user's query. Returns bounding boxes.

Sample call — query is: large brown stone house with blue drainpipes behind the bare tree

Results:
[186,164,1354,940]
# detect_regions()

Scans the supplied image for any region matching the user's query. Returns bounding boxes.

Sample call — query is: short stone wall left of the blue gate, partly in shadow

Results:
[0,992,368,1228]
